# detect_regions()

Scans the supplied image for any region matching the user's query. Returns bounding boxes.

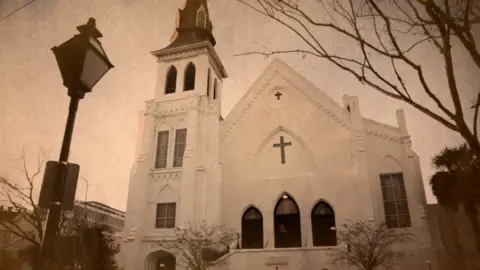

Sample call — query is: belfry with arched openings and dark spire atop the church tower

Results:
[152,0,227,107]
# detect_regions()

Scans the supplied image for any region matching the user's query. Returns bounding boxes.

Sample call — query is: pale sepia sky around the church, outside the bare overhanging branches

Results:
[0,0,480,210]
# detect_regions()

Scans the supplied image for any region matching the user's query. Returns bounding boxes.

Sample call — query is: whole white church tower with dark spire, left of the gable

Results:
[124,0,227,269]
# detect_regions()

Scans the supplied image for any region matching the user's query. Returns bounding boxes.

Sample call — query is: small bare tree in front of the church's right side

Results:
[330,221,410,270]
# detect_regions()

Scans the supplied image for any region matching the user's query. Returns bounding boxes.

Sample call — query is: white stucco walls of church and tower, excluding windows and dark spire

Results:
[122,54,436,270]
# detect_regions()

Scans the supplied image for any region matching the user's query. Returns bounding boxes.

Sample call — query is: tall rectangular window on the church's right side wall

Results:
[380,173,411,228]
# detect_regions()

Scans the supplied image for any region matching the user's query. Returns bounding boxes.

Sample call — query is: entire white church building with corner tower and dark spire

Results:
[121,0,435,270]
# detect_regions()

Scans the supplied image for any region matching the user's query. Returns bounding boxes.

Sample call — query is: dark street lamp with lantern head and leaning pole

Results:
[38,18,113,269]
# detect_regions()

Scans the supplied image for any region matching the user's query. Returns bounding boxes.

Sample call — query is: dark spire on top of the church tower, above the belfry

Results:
[164,0,217,50]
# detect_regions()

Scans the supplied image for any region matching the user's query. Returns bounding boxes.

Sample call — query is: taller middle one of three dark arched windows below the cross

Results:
[274,194,302,248]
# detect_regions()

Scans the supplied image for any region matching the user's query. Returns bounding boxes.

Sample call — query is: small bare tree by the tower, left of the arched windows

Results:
[158,221,237,270]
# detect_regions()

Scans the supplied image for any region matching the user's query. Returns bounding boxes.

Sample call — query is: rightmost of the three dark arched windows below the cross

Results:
[312,201,337,247]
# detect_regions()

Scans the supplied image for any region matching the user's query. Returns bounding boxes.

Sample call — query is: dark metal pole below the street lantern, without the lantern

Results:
[38,97,79,270]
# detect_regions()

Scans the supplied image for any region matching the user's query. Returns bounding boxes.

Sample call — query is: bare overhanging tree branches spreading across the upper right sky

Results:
[237,0,480,153]
